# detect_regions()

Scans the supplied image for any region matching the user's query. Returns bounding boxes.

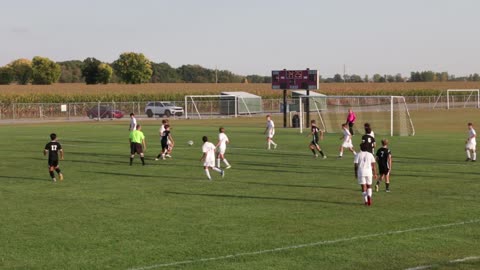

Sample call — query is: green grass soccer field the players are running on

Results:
[0,110,480,270]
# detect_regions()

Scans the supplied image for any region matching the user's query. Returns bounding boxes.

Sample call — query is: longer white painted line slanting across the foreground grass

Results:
[128,219,480,270]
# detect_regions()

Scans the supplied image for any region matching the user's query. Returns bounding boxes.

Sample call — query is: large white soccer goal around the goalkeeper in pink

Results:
[299,96,415,136]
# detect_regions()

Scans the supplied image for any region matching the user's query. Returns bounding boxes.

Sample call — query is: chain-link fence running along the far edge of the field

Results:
[0,95,477,120]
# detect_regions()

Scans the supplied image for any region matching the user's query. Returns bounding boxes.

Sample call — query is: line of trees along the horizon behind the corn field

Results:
[0,52,480,84]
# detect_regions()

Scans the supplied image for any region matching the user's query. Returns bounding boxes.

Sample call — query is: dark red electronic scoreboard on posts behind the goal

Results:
[272,69,319,90]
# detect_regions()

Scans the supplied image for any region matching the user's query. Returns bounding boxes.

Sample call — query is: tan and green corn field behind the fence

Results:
[0,82,480,105]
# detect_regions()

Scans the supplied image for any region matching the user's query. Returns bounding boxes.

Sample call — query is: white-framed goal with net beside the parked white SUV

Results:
[185,95,263,119]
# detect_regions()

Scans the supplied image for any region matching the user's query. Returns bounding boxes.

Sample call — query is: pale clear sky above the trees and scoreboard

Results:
[0,0,480,77]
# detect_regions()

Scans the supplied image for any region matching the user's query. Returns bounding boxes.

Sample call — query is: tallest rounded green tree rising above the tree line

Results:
[113,52,153,84]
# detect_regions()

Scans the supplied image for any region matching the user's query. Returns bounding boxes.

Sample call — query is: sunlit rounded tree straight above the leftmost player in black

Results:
[32,56,62,84]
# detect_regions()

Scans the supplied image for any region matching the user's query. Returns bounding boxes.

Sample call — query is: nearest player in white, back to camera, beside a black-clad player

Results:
[354,143,377,206]
